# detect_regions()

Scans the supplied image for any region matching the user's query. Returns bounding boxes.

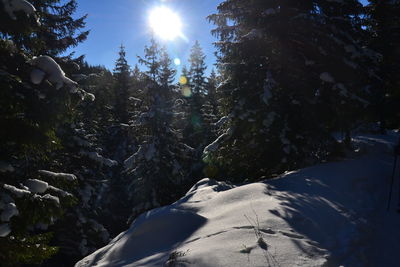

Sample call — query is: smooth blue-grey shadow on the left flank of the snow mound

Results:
[86,206,207,267]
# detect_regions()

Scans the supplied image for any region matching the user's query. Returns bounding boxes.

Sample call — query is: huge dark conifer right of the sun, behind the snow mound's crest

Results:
[204,0,367,180]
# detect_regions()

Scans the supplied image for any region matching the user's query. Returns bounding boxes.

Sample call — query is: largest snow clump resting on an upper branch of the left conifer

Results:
[28,56,78,92]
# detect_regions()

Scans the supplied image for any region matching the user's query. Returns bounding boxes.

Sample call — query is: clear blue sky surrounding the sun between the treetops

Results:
[73,0,222,76]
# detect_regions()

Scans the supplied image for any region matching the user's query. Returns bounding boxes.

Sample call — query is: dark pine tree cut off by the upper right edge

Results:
[365,0,400,131]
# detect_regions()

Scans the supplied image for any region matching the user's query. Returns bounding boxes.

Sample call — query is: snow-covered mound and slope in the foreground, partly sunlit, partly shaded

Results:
[76,133,400,267]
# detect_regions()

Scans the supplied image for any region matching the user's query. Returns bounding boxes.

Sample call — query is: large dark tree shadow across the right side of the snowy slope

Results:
[265,157,390,266]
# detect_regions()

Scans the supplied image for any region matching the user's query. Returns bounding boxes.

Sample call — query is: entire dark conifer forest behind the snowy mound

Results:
[0,0,400,266]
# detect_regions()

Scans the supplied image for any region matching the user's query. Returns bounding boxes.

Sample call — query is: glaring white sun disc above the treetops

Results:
[149,6,182,40]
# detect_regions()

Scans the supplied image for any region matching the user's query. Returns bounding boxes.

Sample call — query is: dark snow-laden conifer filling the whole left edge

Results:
[0,0,94,266]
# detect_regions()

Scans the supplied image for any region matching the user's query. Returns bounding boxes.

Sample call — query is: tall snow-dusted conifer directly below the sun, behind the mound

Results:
[124,39,192,221]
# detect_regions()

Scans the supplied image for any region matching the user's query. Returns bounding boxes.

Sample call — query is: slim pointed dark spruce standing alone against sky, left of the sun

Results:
[114,45,131,123]
